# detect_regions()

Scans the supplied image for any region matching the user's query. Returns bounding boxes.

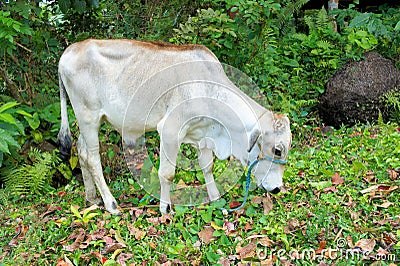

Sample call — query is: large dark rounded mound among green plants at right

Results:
[318,52,400,128]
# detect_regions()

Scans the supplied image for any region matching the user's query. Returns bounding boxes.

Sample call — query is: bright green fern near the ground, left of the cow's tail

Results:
[3,149,60,196]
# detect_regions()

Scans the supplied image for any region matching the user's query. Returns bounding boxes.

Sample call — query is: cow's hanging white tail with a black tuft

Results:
[57,75,72,162]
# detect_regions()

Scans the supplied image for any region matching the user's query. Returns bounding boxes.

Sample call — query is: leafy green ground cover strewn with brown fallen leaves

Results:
[0,124,400,265]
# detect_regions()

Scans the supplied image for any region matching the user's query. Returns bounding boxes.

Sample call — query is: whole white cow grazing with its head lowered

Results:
[58,39,291,214]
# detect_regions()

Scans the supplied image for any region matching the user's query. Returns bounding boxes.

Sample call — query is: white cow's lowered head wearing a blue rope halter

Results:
[249,114,292,193]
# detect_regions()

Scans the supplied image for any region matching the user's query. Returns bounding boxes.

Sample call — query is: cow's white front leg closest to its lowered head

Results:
[198,148,220,201]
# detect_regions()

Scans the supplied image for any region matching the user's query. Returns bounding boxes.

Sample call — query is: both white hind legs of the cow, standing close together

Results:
[79,123,120,215]
